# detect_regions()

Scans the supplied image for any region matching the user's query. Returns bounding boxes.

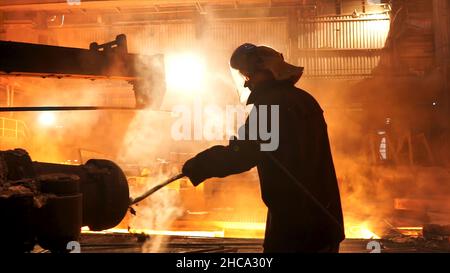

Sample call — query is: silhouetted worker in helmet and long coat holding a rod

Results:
[182,44,345,253]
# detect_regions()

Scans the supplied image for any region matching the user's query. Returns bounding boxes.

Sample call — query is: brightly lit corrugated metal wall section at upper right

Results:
[298,15,390,78]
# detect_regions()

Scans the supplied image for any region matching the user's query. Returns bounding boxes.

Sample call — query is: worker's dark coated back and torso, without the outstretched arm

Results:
[251,82,344,252]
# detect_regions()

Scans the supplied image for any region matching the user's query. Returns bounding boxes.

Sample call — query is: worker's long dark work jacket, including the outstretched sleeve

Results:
[186,83,345,252]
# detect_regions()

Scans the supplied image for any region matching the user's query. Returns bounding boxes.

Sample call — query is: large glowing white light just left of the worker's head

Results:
[165,53,206,92]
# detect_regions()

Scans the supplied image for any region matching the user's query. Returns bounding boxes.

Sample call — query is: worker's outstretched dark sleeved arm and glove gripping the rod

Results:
[183,123,261,186]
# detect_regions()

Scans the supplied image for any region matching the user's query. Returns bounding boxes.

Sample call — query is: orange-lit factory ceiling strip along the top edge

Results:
[0,0,384,28]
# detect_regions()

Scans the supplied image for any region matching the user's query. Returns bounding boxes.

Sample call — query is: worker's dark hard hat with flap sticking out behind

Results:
[230,43,304,83]
